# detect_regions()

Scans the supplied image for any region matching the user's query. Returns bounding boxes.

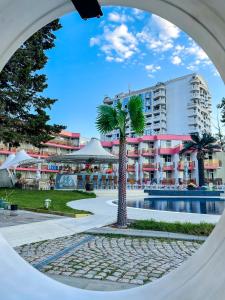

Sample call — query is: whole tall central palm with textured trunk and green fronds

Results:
[96,96,145,227]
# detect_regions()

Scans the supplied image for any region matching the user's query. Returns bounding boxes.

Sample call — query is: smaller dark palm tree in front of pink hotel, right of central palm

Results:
[180,133,221,186]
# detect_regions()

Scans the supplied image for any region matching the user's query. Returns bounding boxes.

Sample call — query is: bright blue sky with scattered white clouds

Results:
[45,7,225,137]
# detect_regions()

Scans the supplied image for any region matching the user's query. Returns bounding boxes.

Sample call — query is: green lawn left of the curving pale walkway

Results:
[0,189,96,217]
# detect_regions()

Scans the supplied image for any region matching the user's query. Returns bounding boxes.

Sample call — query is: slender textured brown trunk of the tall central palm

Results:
[117,138,127,227]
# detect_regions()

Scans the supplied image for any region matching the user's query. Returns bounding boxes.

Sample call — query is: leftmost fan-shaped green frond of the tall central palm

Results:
[96,105,118,134]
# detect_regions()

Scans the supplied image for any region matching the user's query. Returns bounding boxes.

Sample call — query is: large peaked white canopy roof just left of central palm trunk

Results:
[47,138,118,164]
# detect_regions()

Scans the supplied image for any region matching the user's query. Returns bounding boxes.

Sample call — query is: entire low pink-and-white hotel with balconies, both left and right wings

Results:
[0,131,225,184]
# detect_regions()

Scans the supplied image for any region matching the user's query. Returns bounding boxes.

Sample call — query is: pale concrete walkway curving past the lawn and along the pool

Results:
[0,191,220,247]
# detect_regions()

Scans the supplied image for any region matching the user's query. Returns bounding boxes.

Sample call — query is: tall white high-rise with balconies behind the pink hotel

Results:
[102,73,212,140]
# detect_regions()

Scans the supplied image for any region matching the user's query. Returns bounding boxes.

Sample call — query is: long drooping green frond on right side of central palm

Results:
[128,96,145,135]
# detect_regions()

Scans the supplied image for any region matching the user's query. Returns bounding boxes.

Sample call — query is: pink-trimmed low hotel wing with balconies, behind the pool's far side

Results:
[102,135,225,184]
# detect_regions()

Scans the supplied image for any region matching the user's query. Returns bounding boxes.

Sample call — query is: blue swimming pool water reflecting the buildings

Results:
[123,197,225,215]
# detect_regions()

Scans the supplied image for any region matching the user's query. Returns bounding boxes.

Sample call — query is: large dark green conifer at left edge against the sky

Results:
[0,20,65,148]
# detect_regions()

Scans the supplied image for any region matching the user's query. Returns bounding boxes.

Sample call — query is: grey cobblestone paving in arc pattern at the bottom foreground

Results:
[16,234,201,285]
